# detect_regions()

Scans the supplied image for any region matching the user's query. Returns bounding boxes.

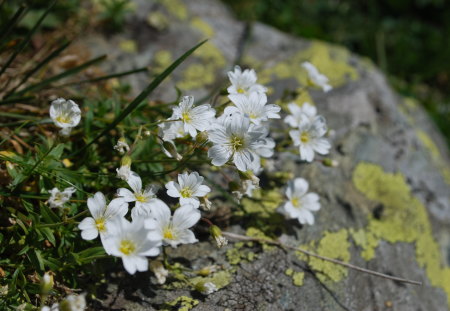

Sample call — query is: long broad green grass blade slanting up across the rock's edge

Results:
[71,40,207,156]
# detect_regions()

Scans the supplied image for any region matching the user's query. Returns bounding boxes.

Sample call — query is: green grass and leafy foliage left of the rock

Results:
[0,1,204,310]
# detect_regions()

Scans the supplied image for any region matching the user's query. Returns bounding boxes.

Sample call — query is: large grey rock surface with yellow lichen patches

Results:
[81,0,450,311]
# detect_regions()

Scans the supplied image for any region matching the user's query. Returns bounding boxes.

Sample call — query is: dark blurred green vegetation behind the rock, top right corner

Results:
[223,0,450,144]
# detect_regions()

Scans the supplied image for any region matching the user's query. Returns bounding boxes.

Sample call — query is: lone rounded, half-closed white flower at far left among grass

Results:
[50,98,81,136]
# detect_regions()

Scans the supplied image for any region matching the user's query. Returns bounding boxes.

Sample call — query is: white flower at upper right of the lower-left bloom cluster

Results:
[166,172,211,207]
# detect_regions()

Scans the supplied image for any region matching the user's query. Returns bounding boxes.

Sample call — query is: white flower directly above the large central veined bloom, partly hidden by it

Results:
[224,92,281,125]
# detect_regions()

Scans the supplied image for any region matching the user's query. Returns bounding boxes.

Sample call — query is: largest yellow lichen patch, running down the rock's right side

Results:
[353,163,450,304]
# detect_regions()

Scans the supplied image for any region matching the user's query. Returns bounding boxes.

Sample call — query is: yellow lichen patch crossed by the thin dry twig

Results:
[296,229,350,282]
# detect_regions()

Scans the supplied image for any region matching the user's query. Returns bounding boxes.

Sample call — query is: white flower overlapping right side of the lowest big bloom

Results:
[145,204,201,247]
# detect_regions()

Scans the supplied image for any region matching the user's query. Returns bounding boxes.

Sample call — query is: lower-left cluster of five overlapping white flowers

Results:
[78,171,211,274]
